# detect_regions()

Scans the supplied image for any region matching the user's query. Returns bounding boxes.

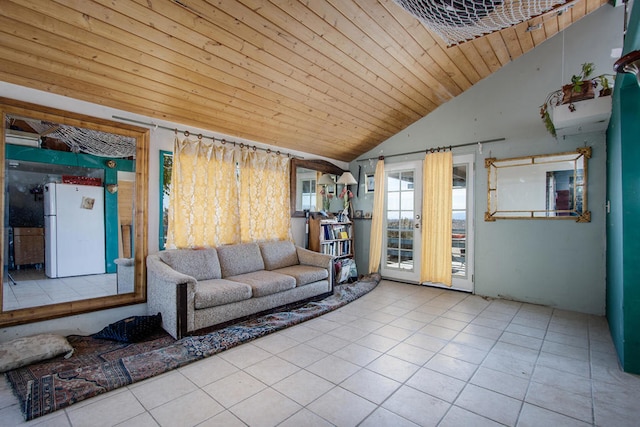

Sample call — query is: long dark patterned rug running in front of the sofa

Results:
[6,275,380,421]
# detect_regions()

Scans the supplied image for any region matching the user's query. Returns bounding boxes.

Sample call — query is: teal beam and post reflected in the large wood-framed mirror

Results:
[5,144,135,273]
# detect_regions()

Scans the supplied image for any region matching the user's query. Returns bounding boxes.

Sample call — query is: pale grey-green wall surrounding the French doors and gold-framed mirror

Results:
[351,5,624,315]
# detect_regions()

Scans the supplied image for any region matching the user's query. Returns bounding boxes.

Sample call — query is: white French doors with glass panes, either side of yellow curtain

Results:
[380,154,474,292]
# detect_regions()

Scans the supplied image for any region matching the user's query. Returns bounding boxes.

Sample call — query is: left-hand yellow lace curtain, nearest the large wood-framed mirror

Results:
[167,138,240,248]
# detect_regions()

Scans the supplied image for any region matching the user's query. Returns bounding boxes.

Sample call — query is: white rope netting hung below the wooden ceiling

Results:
[394,0,566,46]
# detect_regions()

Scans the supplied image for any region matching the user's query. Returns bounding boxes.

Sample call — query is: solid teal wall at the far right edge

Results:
[607,0,640,374]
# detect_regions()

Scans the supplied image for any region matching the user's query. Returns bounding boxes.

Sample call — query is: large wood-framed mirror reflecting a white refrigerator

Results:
[0,98,149,326]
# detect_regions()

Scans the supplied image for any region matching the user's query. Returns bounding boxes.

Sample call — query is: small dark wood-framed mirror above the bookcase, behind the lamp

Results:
[290,159,345,217]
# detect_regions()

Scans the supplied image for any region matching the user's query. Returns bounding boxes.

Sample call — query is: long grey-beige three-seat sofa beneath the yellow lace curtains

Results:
[147,241,333,339]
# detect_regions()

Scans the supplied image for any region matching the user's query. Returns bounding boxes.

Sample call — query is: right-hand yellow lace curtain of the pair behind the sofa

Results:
[239,150,292,242]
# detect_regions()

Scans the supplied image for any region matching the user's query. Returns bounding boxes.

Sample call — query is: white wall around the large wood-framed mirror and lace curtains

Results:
[0,81,347,342]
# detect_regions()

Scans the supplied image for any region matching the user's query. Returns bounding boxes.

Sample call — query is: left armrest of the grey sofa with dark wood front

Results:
[147,254,198,339]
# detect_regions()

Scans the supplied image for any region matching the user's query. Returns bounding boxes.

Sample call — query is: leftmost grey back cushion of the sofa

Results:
[159,248,222,280]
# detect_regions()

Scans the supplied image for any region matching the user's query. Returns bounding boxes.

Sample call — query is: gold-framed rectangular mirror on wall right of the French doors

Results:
[485,147,591,222]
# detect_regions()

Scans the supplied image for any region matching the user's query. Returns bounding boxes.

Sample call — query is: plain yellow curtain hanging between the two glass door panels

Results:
[420,151,453,286]
